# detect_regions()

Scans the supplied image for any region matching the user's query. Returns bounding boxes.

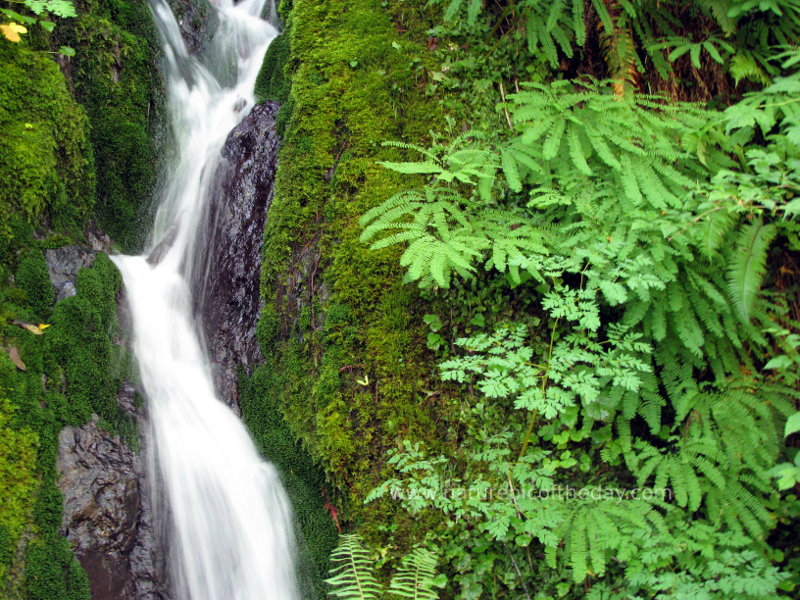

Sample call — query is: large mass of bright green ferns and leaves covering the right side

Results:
[361,22,800,599]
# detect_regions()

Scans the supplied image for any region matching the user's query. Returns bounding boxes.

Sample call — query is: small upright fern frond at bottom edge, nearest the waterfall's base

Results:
[325,534,383,600]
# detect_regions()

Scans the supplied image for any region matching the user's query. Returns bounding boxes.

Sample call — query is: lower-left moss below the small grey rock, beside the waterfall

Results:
[0,251,130,599]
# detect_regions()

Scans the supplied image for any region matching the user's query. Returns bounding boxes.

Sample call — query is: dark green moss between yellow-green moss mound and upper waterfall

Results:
[62,0,161,251]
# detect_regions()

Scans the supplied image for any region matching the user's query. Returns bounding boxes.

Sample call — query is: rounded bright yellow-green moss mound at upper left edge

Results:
[0,43,94,245]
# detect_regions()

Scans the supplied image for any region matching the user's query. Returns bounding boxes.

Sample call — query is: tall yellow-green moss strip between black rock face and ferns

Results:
[255,0,454,552]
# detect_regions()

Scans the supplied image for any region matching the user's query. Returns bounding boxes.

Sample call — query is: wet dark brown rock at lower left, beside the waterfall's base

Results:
[58,418,168,600]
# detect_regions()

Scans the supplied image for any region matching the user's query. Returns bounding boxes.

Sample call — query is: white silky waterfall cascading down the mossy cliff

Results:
[114,0,299,600]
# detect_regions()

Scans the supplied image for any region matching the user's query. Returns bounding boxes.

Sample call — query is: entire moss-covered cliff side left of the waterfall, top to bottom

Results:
[0,0,159,600]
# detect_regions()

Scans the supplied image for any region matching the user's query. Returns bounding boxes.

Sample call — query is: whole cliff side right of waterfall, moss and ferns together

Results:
[259,0,800,600]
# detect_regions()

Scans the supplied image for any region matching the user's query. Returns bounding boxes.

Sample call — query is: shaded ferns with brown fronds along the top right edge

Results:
[430,0,800,92]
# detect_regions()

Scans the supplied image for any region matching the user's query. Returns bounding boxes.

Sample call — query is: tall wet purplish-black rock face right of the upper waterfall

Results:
[194,103,279,410]
